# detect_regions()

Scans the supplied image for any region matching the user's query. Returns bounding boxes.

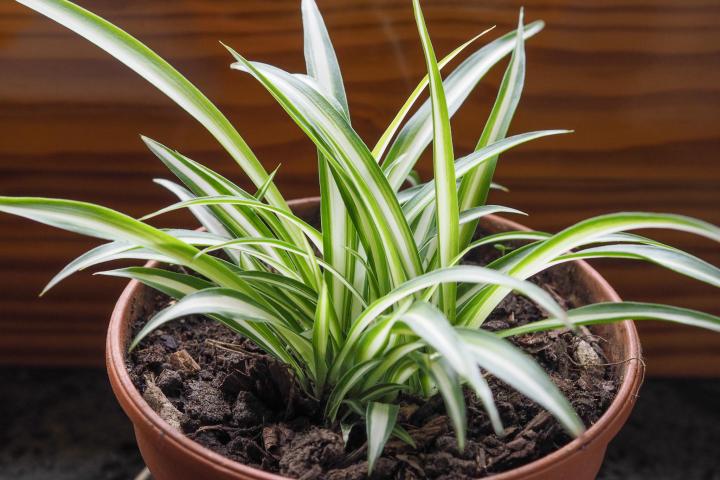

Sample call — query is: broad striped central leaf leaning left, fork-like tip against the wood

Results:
[228,48,421,284]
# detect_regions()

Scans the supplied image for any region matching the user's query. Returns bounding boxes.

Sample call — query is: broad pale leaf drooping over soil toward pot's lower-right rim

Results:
[457,328,585,436]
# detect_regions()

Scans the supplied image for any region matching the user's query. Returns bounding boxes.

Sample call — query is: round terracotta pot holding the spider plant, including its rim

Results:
[106,198,643,480]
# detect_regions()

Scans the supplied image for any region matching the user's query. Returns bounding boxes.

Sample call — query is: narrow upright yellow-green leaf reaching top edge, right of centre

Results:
[413,0,459,322]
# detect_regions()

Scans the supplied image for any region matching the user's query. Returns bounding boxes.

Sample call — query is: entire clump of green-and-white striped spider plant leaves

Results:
[5,0,720,469]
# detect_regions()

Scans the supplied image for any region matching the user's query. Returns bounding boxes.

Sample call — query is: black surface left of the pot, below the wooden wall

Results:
[0,367,143,480]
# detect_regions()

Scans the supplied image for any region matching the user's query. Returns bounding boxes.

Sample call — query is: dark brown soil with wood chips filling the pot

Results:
[127,244,618,480]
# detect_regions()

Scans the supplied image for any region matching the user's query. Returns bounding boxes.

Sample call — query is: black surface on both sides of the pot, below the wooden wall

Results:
[0,367,720,480]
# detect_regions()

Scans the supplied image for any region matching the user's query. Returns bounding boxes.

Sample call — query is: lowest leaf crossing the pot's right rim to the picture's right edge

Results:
[497,302,720,337]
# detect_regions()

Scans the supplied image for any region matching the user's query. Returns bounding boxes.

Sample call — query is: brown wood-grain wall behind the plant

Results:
[0,0,720,375]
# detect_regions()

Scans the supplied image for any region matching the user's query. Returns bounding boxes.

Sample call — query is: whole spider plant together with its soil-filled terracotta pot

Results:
[5,0,720,479]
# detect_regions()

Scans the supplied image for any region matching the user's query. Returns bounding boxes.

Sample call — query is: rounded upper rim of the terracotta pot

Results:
[105,197,644,480]
